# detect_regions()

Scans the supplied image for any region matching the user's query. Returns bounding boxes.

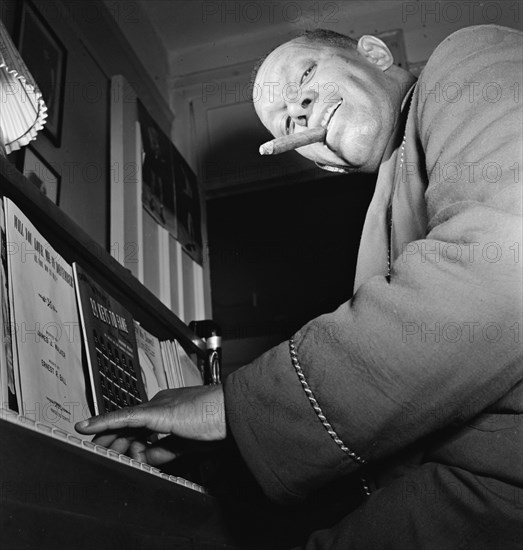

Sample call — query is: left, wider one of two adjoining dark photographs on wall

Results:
[138,102,177,237]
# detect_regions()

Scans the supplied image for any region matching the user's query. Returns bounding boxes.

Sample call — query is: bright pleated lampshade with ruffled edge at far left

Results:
[0,17,47,154]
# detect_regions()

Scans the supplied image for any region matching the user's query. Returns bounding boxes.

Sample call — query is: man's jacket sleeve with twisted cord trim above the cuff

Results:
[225,26,523,508]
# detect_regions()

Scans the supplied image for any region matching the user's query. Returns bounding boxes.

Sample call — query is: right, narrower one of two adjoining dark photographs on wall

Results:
[172,149,203,264]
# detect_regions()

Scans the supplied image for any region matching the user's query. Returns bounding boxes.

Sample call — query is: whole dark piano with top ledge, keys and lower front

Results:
[0,157,302,550]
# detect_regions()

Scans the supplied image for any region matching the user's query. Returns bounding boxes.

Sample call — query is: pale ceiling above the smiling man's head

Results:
[109,0,521,88]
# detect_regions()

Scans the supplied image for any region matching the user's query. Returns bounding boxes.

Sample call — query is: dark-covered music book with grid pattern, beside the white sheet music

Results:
[73,263,147,414]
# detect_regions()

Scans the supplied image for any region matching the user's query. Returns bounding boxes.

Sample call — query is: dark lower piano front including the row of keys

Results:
[0,409,290,550]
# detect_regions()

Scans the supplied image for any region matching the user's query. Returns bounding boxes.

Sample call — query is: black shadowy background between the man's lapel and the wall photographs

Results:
[207,175,375,350]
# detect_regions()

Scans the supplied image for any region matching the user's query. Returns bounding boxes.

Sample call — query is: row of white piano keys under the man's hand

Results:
[0,407,207,494]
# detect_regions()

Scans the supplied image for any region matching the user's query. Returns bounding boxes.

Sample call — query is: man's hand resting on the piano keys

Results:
[75,385,226,465]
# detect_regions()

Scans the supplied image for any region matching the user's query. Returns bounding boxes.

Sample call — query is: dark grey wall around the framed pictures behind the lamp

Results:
[2,0,110,248]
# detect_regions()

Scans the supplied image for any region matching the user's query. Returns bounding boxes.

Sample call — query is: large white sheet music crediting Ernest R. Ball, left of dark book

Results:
[3,198,91,433]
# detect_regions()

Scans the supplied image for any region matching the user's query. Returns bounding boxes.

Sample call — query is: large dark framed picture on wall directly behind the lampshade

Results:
[18,0,67,147]
